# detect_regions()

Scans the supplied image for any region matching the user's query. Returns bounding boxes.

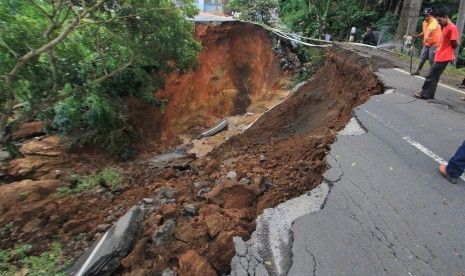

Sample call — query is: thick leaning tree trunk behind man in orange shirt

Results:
[394,0,422,42]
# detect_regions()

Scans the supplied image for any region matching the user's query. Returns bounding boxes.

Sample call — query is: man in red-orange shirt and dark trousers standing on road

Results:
[413,10,459,99]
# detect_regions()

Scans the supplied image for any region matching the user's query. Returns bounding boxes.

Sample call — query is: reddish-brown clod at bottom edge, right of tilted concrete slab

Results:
[178,250,218,276]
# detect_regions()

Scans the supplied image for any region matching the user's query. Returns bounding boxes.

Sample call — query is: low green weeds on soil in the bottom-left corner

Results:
[0,243,71,276]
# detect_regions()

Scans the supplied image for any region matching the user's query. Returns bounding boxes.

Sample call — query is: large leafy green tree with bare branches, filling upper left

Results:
[0,0,200,157]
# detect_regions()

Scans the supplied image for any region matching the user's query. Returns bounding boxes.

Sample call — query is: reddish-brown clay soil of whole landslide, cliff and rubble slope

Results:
[0,20,383,275]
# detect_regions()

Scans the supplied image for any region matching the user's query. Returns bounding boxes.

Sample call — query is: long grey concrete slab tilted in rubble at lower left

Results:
[68,205,144,276]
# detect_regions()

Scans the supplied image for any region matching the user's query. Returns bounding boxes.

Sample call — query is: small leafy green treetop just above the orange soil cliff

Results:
[228,0,279,24]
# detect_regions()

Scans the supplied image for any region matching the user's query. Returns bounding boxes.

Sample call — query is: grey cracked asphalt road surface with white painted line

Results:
[288,69,465,275]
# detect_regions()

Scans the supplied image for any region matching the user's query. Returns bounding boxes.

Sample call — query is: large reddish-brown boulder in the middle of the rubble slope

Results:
[205,180,260,209]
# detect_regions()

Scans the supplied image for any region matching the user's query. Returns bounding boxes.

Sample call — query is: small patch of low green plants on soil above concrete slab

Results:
[55,167,125,197]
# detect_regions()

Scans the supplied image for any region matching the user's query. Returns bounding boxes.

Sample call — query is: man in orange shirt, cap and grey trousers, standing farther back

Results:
[411,8,441,75]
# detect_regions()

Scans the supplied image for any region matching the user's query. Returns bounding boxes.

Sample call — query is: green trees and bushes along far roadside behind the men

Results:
[229,0,465,64]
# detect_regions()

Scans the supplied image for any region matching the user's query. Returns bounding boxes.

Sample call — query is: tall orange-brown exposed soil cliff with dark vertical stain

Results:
[129,22,289,150]
